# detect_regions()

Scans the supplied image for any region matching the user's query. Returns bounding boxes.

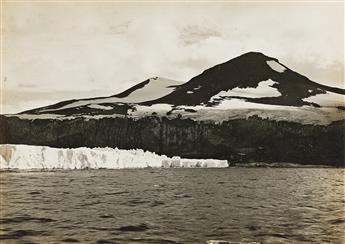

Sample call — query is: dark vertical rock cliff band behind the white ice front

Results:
[0,116,345,166]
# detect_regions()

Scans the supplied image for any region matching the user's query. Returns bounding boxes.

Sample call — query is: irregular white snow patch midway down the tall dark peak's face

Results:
[210,79,282,102]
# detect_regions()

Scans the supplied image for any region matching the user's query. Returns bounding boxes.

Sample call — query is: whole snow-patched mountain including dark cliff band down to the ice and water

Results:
[0,52,345,165]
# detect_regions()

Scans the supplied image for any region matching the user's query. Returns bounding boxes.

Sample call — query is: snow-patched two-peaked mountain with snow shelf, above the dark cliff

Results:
[21,52,345,123]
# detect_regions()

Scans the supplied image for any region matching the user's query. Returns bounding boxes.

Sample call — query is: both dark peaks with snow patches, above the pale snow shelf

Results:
[25,52,345,114]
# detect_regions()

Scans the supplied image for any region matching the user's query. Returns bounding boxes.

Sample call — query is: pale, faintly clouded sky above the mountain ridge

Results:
[0,1,344,113]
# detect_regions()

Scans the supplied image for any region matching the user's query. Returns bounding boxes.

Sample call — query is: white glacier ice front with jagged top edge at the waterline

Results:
[0,144,228,170]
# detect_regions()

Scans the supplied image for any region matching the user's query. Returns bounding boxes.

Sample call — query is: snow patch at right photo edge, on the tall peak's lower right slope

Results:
[302,92,345,107]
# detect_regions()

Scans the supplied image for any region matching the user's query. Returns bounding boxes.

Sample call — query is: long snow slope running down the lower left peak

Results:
[41,77,183,112]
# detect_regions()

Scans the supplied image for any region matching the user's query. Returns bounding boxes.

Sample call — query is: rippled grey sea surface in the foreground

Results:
[0,168,345,243]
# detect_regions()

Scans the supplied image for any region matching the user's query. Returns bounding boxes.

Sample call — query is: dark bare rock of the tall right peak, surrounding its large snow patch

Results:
[151,52,343,106]
